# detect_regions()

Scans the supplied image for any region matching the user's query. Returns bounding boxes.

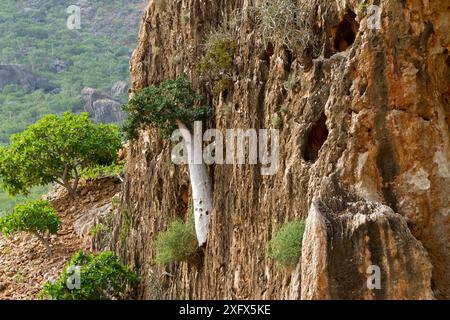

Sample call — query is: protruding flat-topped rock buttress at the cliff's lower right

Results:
[301,199,433,300]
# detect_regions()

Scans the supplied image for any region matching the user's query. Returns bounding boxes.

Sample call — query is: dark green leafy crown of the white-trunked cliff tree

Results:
[123,74,214,140]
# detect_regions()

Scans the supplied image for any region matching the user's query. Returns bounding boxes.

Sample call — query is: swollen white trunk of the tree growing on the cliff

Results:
[177,121,213,246]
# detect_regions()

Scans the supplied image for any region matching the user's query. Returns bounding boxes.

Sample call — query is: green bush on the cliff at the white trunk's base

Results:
[155,218,198,265]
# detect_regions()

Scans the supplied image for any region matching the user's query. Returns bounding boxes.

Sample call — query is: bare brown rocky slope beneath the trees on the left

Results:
[0,177,120,300]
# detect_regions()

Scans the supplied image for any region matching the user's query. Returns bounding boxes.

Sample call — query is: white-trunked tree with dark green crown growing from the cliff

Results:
[123,75,214,246]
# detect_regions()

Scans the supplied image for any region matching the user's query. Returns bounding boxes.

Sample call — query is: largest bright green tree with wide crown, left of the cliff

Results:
[0,113,122,198]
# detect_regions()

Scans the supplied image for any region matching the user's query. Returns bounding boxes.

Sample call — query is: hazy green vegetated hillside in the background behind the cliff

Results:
[0,0,146,212]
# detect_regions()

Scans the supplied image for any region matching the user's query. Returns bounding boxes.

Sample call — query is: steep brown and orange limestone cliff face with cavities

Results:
[108,0,450,299]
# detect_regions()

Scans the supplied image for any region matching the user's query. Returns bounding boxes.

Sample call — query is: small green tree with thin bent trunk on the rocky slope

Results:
[0,200,61,256]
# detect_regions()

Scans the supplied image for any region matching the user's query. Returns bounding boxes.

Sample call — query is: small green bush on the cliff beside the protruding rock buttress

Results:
[268,220,305,268]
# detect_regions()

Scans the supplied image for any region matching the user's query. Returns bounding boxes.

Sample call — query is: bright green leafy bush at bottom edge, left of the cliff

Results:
[38,251,139,300]
